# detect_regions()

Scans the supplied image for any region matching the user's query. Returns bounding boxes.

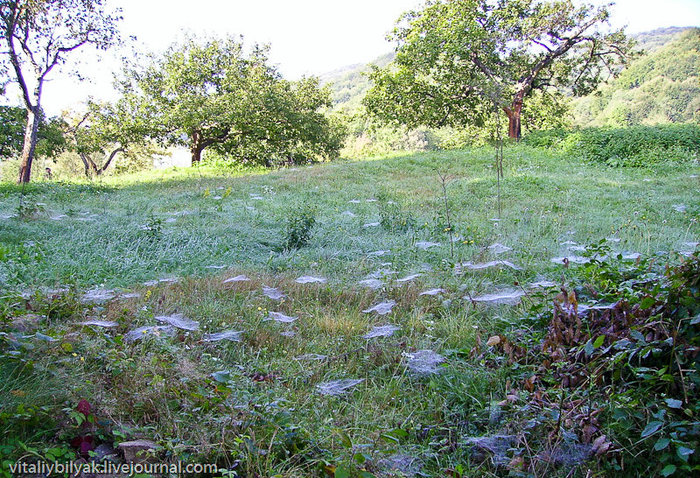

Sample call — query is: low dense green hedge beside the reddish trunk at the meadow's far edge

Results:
[524,124,700,166]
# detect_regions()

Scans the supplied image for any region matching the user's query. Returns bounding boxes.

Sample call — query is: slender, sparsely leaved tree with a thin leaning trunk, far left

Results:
[0,0,121,182]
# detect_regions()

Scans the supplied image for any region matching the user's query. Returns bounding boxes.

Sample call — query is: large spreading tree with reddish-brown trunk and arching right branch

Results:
[365,0,633,138]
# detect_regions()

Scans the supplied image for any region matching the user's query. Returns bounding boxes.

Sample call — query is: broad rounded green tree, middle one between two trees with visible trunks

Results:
[121,37,341,164]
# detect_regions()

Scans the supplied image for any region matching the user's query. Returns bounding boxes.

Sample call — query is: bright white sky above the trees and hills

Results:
[2,0,700,115]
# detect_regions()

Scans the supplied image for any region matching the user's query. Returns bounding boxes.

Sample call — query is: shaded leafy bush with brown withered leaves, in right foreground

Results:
[462,248,700,476]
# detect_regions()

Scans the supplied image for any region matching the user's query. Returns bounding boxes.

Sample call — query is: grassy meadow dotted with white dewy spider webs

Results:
[0,146,700,477]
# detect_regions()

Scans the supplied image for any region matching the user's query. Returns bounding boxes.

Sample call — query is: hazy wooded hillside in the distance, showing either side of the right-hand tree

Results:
[320,27,700,126]
